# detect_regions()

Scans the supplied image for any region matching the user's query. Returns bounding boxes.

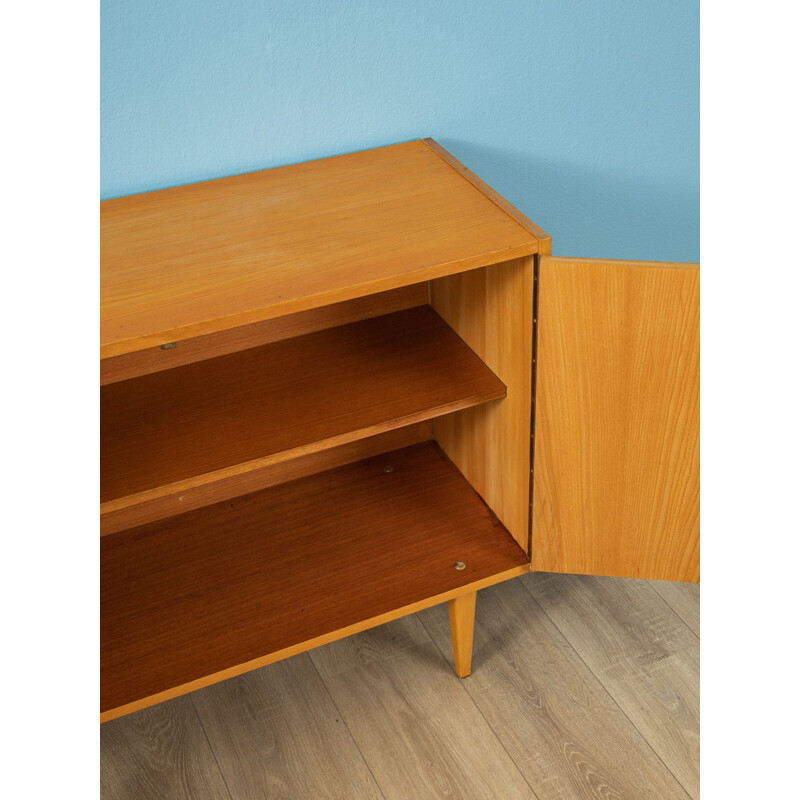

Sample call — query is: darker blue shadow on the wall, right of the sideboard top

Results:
[434,137,700,261]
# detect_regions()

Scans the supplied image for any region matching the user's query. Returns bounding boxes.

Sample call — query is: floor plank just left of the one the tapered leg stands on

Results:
[310,623,535,800]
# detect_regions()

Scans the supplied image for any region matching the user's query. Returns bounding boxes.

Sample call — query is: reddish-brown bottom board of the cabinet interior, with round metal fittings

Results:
[100,442,528,720]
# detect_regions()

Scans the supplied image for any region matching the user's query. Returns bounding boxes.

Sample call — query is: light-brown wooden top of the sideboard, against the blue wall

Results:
[100,140,547,358]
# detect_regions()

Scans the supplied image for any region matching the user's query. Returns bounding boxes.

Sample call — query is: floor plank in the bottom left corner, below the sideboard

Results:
[100,697,231,800]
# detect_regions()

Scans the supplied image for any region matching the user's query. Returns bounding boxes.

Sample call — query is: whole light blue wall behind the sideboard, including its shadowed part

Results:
[101,0,699,261]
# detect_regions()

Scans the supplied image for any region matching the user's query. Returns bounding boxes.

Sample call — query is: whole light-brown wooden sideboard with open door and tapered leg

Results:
[100,139,699,721]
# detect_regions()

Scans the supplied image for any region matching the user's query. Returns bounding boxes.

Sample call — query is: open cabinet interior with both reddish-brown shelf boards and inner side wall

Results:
[101,257,533,719]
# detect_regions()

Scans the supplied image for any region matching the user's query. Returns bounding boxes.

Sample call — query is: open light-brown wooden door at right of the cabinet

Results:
[532,257,700,581]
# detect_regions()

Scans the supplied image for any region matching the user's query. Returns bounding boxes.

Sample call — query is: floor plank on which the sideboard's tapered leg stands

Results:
[418,580,687,800]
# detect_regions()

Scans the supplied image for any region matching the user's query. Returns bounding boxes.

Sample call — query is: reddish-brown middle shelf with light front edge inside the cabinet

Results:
[101,306,506,532]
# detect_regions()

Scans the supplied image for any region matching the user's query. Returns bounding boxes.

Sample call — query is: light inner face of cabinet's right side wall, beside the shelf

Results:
[431,256,533,551]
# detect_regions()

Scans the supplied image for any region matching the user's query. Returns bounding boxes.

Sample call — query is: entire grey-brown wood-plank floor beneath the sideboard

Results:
[100,573,700,800]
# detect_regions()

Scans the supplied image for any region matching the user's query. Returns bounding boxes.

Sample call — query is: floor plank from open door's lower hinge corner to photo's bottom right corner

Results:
[523,574,700,798]
